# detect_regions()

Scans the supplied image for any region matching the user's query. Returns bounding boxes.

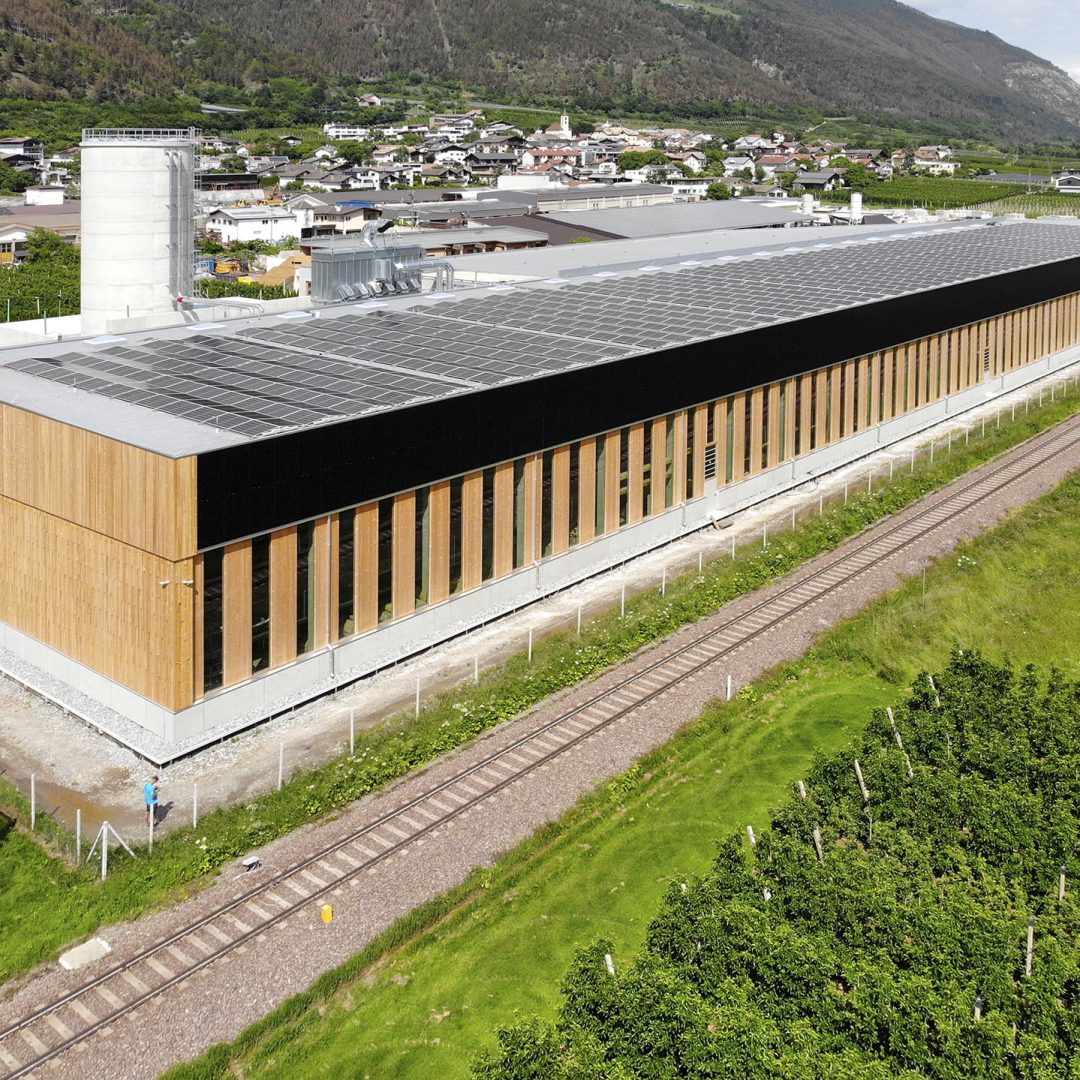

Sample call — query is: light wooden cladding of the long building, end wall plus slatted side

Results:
[0,295,1080,711]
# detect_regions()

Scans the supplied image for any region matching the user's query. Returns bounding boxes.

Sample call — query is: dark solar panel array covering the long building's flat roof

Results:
[5,224,1080,437]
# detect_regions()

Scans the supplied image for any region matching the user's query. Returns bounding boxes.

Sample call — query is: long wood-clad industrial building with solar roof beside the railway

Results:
[0,213,1080,757]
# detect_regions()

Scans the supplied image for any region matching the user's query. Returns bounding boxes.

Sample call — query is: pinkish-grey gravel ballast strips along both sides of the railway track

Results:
[6,393,1080,1080]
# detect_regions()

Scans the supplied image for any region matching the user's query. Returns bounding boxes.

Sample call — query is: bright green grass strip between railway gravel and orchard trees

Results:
[172,442,1080,1080]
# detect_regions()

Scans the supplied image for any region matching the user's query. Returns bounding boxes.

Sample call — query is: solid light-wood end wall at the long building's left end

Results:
[0,405,198,710]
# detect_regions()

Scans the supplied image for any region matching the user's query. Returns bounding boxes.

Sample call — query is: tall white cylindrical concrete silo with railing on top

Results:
[81,127,199,334]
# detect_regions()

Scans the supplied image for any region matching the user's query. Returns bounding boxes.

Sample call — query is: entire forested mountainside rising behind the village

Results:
[0,0,1080,141]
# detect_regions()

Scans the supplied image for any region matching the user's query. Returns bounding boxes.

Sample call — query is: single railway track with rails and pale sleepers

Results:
[0,416,1080,1080]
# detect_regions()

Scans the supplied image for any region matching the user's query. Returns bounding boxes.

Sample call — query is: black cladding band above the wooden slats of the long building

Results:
[198,258,1080,550]
